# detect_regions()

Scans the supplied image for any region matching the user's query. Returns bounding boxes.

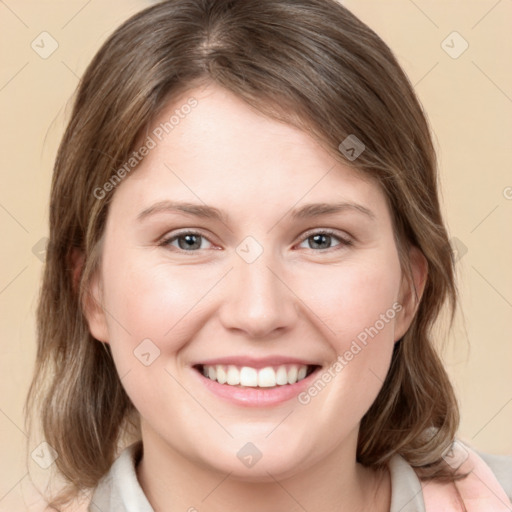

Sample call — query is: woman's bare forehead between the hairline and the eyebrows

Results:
[110,85,384,219]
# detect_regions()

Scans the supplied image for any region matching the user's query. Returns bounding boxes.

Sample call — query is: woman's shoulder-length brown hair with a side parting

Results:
[28,0,459,504]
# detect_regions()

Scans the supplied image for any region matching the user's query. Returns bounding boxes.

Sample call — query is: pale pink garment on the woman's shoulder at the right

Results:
[421,441,512,512]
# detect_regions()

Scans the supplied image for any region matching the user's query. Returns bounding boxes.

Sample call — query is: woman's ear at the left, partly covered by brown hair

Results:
[71,247,109,343]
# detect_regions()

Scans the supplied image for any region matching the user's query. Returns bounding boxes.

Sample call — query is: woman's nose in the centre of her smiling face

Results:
[219,252,298,339]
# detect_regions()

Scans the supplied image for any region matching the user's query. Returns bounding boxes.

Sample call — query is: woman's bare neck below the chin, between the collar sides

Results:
[137,426,391,512]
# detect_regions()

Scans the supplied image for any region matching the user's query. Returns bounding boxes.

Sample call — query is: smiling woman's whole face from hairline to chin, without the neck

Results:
[87,81,422,479]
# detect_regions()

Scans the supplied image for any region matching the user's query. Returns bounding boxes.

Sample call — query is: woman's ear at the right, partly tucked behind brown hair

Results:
[395,246,428,341]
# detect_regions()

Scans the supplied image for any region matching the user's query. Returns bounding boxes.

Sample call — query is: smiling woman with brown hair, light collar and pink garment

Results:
[29,0,512,512]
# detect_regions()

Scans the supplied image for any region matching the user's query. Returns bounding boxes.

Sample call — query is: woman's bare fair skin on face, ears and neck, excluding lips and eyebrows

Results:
[86,84,427,512]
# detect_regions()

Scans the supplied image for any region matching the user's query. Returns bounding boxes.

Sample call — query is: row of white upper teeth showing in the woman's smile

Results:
[203,364,308,388]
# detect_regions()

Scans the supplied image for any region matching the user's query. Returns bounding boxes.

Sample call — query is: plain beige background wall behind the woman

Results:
[0,0,512,511]
